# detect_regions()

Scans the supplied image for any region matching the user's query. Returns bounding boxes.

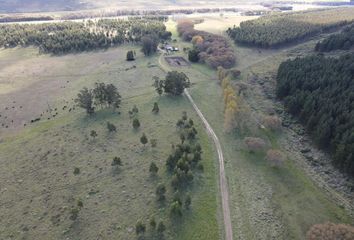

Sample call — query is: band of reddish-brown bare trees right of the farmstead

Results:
[177,20,236,68]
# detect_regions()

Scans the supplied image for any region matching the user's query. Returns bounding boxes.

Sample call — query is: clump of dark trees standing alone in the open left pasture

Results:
[75,83,121,114]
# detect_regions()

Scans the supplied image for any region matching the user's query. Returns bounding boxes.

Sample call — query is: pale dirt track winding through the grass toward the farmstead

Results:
[159,54,233,240]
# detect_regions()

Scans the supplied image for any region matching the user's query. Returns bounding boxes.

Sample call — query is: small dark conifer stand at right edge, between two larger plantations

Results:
[315,24,354,52]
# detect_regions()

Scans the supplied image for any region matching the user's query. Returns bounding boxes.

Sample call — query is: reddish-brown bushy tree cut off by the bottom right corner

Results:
[306,222,354,240]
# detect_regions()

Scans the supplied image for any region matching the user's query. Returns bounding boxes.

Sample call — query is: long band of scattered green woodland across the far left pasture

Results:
[0,19,171,54]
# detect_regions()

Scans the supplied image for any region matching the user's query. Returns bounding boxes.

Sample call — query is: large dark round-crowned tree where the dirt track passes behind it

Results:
[164,71,190,96]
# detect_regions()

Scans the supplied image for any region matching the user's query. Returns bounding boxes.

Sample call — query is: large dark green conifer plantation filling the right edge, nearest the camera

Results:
[277,54,354,176]
